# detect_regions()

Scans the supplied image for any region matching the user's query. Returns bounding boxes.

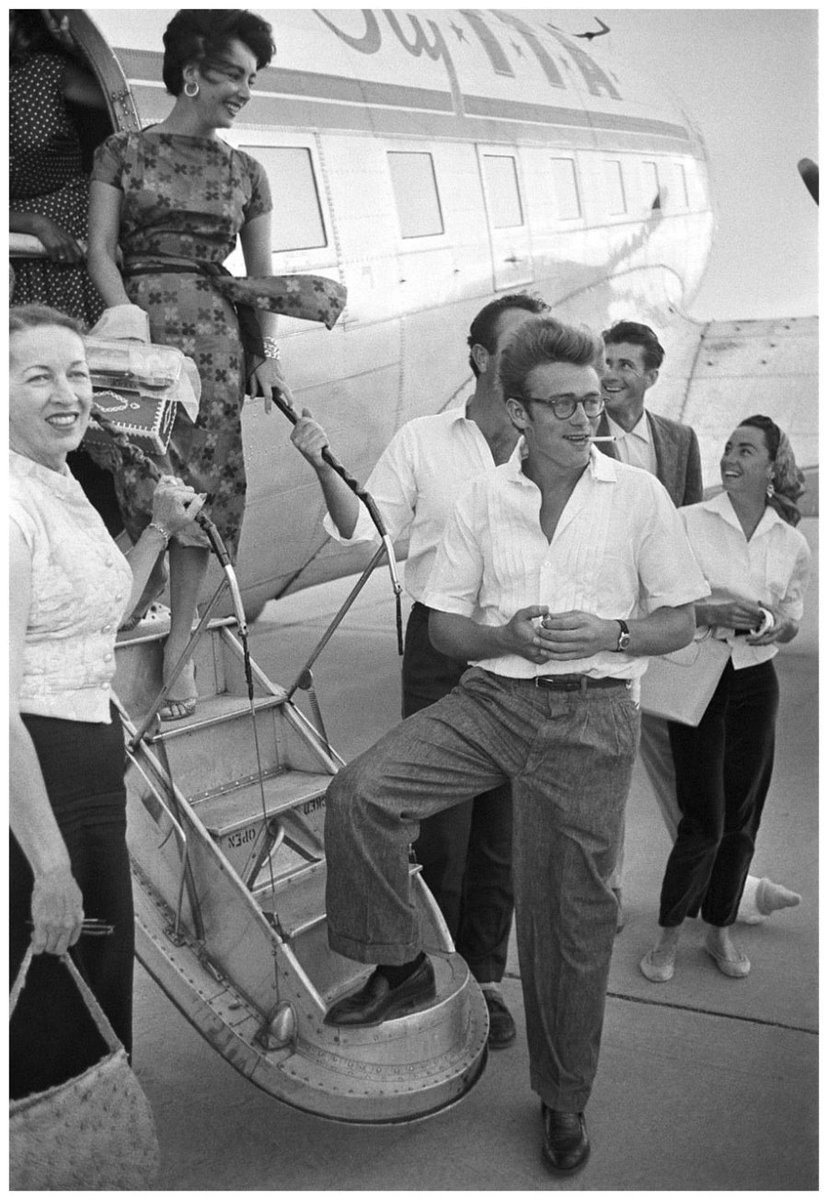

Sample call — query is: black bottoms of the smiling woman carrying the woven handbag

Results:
[8,710,134,1098]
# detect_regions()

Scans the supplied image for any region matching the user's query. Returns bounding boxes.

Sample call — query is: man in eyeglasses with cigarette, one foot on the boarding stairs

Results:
[325,317,708,1172]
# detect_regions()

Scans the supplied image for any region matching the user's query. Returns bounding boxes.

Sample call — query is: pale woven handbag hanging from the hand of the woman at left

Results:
[8,947,160,1192]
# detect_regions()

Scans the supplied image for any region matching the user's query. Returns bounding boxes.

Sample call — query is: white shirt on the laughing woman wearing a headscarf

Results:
[679,492,811,671]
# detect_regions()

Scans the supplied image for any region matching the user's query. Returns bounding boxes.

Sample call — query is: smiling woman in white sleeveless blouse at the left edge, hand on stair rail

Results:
[8,306,203,1097]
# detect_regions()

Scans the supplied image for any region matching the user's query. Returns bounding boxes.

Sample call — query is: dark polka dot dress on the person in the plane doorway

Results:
[8,54,103,325]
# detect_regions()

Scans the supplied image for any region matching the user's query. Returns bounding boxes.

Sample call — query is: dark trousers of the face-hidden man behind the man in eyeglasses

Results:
[402,604,515,983]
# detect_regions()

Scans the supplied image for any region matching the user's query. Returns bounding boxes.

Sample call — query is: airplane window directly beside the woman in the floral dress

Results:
[241,145,328,253]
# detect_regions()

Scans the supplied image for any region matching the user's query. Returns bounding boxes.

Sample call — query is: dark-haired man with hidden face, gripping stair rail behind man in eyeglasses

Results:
[293,293,548,1050]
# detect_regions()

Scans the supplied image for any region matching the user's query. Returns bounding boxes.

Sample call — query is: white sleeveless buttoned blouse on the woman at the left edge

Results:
[8,450,132,725]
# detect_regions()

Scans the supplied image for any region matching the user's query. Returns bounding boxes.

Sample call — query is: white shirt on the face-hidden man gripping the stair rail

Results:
[324,408,494,604]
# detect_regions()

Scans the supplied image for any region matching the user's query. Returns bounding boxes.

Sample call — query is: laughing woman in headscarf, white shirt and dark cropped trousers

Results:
[641,416,810,983]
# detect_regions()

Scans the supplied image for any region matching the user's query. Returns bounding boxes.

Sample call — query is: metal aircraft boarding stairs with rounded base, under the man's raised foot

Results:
[114,618,488,1123]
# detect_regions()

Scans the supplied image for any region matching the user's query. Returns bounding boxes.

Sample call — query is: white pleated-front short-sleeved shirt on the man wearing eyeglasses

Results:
[425,443,709,679]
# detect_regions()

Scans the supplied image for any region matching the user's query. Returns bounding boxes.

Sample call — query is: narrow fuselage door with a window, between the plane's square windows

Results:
[475,142,535,292]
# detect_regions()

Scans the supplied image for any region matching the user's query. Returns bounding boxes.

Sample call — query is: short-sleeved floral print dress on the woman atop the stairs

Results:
[92,127,271,559]
